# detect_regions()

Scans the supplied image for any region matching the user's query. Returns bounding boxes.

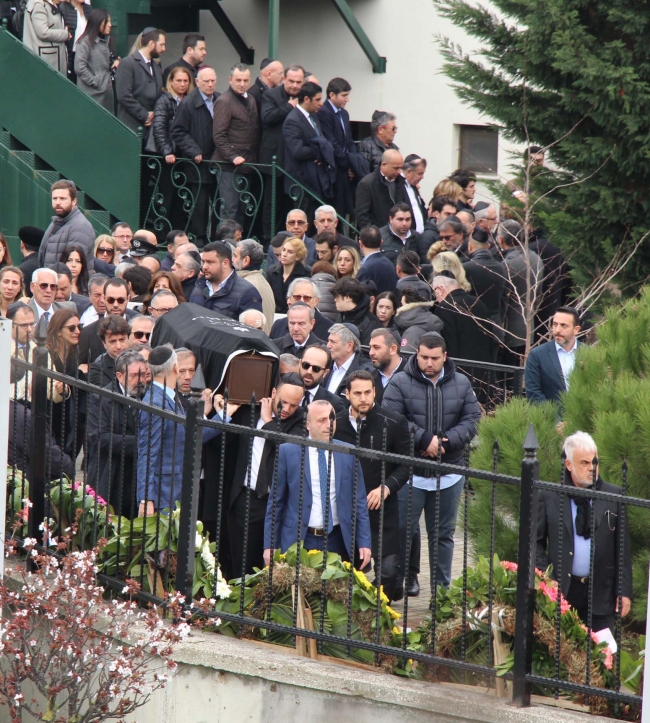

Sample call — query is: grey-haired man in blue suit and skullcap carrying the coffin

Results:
[137,346,218,517]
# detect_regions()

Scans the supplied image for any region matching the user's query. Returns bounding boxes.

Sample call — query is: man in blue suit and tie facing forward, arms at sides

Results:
[264,400,371,569]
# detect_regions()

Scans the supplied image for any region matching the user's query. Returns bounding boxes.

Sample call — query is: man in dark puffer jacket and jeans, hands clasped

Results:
[382,333,481,594]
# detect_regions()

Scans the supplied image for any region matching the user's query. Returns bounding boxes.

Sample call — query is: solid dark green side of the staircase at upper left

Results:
[0,21,141,252]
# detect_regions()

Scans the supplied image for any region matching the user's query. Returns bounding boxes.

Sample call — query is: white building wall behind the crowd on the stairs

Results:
[163,0,510,206]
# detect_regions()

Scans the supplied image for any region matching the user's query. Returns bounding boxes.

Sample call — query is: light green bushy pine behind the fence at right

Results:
[468,287,650,619]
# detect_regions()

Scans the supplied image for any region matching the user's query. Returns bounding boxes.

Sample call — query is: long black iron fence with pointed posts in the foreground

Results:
[8,338,650,705]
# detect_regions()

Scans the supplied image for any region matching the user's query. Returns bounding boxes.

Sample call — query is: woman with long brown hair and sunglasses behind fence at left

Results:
[45,309,86,456]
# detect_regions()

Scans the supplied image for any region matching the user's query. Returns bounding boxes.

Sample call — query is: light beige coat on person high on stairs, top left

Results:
[23,0,68,76]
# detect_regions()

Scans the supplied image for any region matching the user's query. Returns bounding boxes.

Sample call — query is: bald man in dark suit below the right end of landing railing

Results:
[356,150,409,229]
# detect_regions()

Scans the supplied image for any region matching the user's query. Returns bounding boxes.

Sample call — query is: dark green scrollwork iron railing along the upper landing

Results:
[142,155,357,240]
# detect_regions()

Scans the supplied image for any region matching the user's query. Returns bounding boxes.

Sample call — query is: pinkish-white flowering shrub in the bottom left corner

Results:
[0,539,189,723]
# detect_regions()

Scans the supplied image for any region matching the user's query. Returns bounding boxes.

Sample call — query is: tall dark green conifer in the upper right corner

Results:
[434,0,650,288]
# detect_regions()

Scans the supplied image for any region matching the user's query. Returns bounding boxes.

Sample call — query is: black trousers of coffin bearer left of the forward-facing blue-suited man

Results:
[228,487,269,577]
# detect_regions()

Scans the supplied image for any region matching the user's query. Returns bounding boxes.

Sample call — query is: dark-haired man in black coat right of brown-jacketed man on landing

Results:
[259,65,305,241]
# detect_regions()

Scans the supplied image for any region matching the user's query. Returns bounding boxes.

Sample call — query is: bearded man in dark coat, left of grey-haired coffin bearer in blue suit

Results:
[86,350,148,518]
